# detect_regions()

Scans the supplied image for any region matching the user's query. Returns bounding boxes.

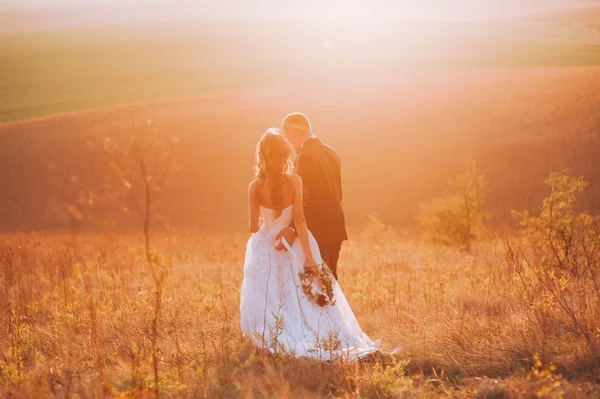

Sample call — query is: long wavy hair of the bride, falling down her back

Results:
[254,128,293,217]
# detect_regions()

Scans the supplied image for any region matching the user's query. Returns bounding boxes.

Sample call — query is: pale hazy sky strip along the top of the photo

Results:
[0,0,600,20]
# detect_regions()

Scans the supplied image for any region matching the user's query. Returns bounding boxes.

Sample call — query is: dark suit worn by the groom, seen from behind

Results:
[295,137,348,279]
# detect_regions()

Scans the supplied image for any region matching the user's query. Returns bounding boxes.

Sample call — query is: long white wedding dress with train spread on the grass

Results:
[240,206,380,361]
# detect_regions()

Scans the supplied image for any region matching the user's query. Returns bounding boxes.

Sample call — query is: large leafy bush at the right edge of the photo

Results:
[507,170,600,358]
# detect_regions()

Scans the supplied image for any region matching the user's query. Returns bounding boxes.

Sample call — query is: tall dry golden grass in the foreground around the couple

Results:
[0,228,600,398]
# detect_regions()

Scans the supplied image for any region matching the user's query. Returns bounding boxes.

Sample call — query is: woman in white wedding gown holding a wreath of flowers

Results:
[240,129,380,361]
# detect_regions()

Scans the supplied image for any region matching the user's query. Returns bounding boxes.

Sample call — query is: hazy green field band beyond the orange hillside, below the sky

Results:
[0,24,600,122]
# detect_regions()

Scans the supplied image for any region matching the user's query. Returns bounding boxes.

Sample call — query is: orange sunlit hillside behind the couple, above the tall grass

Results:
[0,67,600,231]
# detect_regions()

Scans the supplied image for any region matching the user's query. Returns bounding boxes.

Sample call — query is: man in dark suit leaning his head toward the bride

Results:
[277,112,348,280]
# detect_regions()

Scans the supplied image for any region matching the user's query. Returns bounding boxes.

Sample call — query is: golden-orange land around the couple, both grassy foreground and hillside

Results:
[0,63,600,398]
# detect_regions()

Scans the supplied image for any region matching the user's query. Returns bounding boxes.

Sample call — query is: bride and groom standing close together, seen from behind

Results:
[240,113,380,361]
